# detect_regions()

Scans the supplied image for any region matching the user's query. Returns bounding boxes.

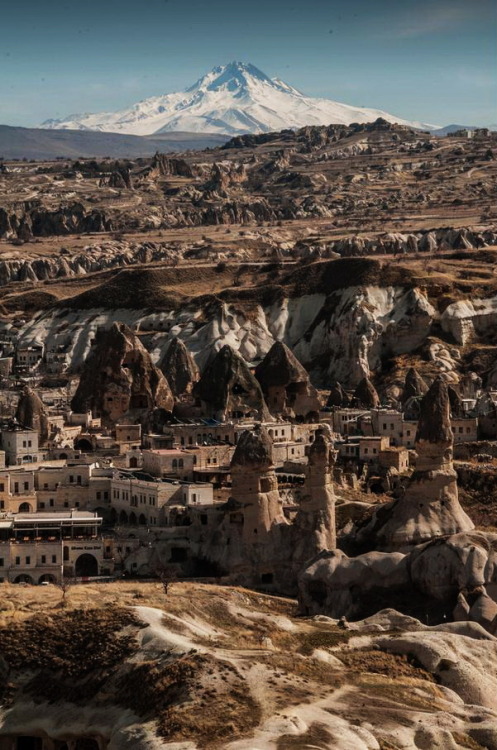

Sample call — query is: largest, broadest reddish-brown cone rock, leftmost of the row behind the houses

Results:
[72,323,174,426]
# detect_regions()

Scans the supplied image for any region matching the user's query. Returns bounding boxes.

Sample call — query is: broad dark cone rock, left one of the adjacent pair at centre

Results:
[193,345,269,421]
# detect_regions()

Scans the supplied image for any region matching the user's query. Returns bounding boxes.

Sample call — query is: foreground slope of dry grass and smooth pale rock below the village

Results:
[0,583,497,750]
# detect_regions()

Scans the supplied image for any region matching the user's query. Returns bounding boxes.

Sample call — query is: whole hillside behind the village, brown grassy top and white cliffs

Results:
[6,253,497,388]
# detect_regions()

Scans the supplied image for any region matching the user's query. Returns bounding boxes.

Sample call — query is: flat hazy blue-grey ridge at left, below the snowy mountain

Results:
[0,125,228,160]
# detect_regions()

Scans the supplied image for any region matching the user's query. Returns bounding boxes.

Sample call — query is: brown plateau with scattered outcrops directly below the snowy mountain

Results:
[0,119,496,242]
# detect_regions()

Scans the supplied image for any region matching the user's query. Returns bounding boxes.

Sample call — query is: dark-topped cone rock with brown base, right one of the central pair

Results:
[255,341,320,417]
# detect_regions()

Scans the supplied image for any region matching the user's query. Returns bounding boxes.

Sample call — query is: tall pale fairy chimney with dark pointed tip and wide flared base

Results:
[359,377,474,550]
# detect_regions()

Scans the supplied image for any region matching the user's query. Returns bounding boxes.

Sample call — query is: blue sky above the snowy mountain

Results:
[0,0,497,126]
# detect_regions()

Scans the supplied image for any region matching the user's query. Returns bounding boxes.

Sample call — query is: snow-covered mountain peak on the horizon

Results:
[41,62,435,135]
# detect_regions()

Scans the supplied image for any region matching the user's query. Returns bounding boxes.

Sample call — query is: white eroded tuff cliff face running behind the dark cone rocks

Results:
[16,286,435,385]
